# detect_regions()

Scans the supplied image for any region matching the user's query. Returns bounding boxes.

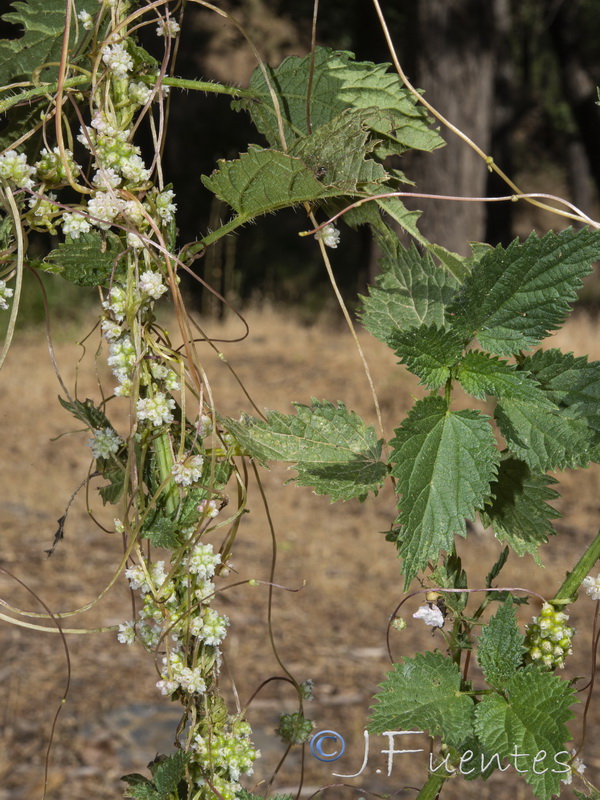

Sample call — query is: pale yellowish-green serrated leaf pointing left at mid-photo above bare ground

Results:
[225,399,387,502]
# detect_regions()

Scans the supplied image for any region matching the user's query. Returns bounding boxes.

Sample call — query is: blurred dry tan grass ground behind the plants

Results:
[0,309,600,800]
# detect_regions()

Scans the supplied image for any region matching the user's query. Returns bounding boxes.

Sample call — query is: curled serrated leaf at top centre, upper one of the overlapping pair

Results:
[233,47,443,156]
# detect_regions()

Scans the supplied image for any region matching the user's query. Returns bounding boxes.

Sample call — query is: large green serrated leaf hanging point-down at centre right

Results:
[390,397,499,585]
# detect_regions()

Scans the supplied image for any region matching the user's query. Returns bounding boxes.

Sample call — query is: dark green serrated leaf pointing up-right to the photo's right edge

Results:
[449,229,600,356]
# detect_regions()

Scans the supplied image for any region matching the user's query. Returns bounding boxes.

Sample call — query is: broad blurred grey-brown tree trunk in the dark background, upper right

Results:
[409,0,497,255]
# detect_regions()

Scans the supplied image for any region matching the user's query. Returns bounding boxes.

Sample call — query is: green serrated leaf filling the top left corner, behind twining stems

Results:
[0,0,98,85]
